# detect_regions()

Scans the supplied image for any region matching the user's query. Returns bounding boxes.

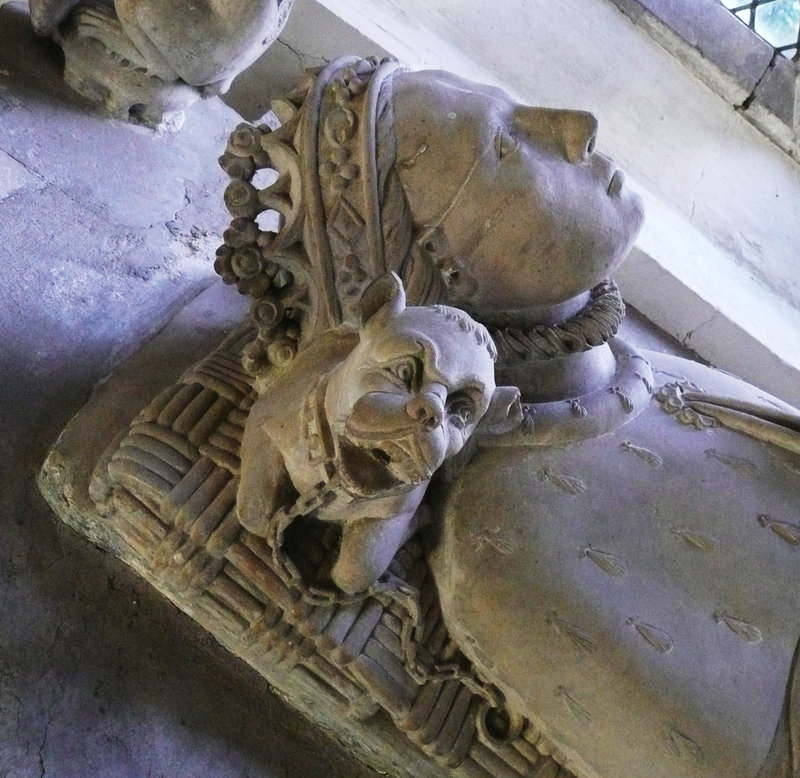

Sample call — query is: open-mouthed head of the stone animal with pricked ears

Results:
[325,273,518,494]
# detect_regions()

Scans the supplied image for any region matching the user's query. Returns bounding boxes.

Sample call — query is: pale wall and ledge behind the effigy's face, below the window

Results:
[304,0,800,406]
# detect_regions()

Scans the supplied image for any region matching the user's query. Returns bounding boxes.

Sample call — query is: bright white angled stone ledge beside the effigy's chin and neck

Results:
[616,189,800,407]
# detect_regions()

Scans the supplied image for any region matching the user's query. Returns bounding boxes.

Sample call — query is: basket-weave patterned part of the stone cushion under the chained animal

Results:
[86,326,572,778]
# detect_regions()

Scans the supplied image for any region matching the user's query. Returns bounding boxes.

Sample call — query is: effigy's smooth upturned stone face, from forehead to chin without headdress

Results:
[394,73,643,320]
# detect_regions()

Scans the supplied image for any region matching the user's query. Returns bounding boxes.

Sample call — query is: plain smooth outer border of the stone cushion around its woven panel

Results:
[39,286,476,778]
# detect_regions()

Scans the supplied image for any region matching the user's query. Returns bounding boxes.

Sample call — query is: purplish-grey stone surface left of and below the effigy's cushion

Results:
[0,9,374,778]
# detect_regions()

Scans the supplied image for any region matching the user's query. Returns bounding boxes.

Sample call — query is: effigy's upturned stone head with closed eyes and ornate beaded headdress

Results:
[216,57,642,373]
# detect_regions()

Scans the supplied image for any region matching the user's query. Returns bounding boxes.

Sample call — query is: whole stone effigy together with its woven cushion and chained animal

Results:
[40,57,800,778]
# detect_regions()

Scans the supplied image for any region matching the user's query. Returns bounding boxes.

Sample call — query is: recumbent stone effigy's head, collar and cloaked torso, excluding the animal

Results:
[211,59,800,778]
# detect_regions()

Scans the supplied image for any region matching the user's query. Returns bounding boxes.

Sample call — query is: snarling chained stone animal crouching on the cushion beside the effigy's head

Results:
[238,274,518,593]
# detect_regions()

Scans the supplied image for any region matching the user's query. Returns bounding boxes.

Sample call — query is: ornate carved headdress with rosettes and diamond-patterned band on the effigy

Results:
[215,57,435,373]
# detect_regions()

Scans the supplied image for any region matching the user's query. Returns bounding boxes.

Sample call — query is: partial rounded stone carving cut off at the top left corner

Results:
[29,0,293,129]
